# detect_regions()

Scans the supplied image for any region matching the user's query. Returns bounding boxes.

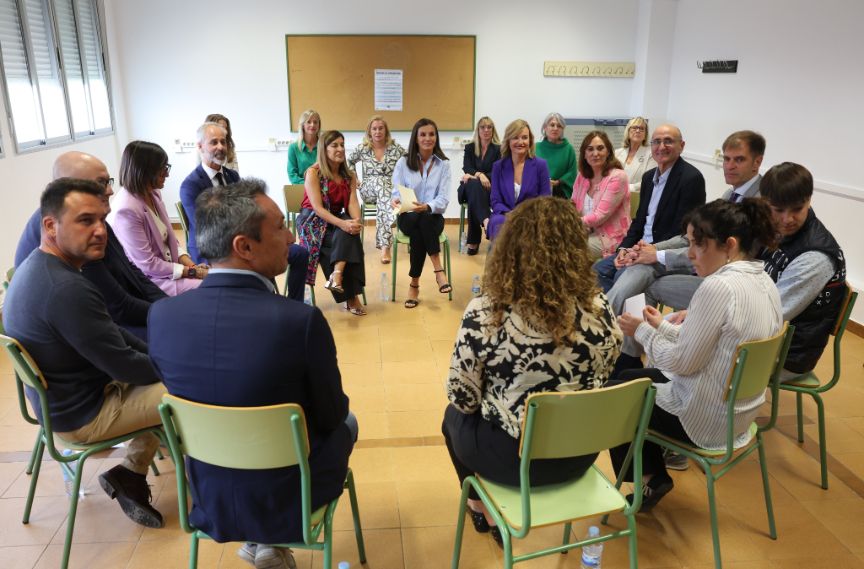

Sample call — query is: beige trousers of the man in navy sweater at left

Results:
[57,381,168,474]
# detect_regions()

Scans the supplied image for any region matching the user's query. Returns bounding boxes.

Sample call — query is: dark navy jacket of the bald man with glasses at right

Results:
[620,158,705,248]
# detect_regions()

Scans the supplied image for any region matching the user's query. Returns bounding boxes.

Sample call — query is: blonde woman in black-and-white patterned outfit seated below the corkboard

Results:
[348,115,405,265]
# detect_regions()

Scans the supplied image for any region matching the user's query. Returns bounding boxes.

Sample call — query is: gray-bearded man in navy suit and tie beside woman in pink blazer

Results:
[180,122,309,302]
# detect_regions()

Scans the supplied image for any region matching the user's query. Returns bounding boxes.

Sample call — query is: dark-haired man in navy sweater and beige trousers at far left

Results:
[3,178,165,528]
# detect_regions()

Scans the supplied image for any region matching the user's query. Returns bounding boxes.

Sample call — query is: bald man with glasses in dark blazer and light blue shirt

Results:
[594,124,705,292]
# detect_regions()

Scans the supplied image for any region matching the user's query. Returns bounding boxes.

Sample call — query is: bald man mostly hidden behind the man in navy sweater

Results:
[15,151,165,340]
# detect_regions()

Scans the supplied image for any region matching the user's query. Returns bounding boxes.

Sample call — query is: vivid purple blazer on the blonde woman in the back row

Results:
[487,156,552,239]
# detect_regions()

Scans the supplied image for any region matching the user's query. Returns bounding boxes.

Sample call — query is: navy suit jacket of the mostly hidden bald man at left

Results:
[15,209,166,332]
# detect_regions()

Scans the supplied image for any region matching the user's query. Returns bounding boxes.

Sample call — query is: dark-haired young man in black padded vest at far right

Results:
[645,162,847,381]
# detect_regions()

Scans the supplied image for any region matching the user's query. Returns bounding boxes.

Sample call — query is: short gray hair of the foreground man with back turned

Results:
[195,178,267,262]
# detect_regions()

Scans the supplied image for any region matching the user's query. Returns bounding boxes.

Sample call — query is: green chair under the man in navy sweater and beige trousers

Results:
[0,335,164,569]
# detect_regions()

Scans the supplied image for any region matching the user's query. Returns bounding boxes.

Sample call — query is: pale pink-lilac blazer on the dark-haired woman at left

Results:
[108,188,201,296]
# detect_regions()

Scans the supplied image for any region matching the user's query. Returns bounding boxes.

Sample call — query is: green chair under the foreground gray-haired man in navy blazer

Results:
[159,394,366,569]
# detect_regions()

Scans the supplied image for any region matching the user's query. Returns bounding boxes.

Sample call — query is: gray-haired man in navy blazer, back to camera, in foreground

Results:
[148,179,356,567]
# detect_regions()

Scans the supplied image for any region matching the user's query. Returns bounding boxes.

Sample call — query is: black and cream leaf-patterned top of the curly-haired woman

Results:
[447,293,623,439]
